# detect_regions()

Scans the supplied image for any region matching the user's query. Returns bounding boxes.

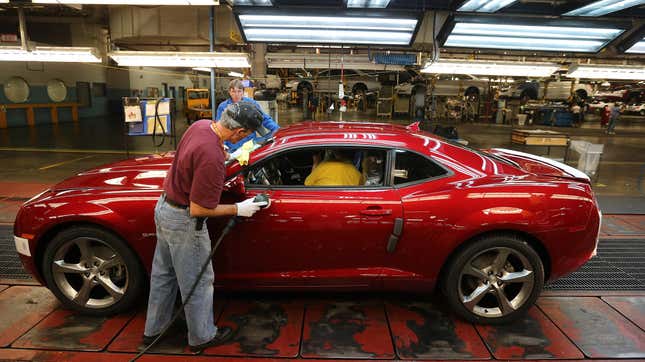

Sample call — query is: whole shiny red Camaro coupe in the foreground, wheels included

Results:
[14,122,601,323]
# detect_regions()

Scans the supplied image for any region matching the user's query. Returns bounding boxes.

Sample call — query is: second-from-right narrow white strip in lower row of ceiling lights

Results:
[421,60,560,77]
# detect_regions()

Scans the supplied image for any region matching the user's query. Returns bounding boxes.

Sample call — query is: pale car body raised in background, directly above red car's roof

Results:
[286,69,381,95]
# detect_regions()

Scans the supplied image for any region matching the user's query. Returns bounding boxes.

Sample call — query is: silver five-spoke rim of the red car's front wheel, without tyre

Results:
[51,237,128,309]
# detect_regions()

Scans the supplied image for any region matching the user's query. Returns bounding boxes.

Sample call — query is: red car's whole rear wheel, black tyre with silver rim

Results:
[441,234,544,324]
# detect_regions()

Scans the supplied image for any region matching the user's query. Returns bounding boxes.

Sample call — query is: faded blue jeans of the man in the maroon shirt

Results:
[144,196,217,346]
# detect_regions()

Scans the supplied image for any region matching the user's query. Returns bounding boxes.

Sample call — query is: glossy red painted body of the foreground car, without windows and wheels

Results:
[14,122,601,321]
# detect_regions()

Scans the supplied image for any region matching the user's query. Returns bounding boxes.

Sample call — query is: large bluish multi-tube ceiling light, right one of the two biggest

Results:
[444,22,624,52]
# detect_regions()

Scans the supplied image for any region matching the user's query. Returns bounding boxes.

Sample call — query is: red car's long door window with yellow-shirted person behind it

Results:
[245,147,387,187]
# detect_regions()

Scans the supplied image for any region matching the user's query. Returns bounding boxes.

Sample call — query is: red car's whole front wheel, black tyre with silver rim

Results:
[42,226,146,316]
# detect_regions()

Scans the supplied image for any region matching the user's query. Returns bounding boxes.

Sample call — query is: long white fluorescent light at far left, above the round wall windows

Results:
[0,46,101,63]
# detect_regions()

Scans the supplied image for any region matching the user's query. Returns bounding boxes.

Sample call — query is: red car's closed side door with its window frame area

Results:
[215,149,402,289]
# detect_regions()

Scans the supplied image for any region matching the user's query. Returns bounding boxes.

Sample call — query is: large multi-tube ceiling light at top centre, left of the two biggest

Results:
[239,14,418,45]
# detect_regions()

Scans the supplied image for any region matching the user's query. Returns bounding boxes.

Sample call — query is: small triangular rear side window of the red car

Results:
[392,150,448,185]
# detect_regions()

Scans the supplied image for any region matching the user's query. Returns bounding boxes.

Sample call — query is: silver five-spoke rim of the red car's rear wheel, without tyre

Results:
[459,247,535,318]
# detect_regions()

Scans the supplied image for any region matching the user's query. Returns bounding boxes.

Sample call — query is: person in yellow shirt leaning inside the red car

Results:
[305,149,364,186]
